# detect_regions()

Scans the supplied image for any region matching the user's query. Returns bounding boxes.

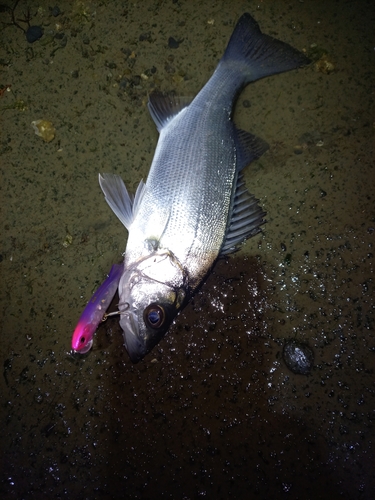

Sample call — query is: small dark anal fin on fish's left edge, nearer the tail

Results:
[147,92,193,132]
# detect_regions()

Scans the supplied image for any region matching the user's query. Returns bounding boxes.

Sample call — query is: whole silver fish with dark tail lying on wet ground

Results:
[99,13,310,363]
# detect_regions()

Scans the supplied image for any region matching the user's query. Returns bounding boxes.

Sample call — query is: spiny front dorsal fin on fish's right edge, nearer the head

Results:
[220,174,266,255]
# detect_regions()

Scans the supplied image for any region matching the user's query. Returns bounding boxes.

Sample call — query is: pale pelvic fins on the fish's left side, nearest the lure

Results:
[99,174,146,231]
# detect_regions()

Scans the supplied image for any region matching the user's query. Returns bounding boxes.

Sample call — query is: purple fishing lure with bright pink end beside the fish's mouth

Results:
[72,264,124,354]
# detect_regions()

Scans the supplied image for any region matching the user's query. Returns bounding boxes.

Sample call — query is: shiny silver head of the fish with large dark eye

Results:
[119,251,188,363]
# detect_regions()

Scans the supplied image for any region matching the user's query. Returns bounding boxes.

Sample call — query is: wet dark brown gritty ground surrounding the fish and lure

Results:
[0,0,375,500]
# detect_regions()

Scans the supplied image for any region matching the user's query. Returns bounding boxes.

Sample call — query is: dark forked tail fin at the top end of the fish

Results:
[221,13,310,83]
